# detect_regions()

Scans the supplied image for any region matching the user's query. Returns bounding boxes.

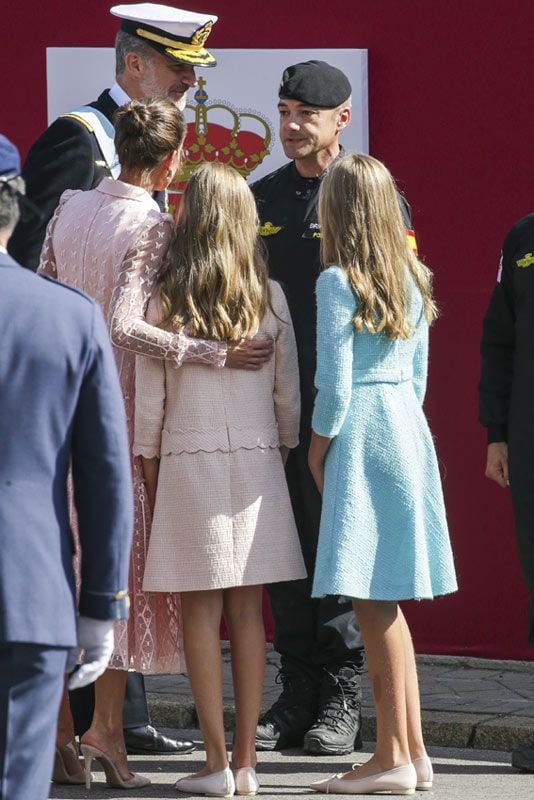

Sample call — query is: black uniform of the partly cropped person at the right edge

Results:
[479,214,534,646]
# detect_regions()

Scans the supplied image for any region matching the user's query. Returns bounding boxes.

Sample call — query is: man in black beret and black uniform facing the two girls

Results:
[252,61,411,755]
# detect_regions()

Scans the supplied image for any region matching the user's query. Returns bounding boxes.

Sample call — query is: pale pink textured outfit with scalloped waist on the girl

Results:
[134,281,306,592]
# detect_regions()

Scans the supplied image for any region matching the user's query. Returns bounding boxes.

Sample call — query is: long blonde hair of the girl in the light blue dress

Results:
[319,154,437,339]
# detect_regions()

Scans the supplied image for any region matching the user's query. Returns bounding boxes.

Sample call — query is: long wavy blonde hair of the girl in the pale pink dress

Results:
[159,162,270,342]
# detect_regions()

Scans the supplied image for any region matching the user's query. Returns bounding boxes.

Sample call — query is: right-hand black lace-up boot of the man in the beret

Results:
[304,666,362,756]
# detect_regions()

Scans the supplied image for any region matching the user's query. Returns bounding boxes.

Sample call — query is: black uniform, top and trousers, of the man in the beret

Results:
[251,161,411,680]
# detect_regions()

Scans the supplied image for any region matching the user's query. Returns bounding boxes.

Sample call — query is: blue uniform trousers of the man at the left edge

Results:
[0,642,68,800]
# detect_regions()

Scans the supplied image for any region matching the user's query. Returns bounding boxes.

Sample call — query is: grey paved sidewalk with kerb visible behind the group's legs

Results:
[146,643,534,752]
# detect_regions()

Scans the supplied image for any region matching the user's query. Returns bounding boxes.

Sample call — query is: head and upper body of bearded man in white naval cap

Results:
[9,3,217,270]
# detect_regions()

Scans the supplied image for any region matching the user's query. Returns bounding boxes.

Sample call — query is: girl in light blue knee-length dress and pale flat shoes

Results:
[309,155,457,794]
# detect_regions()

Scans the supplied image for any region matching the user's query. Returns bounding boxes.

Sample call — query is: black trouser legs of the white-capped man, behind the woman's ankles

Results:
[69,672,150,736]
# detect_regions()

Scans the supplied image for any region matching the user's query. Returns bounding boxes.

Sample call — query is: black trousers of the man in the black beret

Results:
[267,429,364,680]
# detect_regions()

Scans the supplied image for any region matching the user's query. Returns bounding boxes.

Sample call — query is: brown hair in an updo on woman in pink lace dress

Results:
[114,98,186,174]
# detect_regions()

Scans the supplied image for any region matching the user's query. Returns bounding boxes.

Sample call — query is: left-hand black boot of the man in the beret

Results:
[256,669,317,750]
